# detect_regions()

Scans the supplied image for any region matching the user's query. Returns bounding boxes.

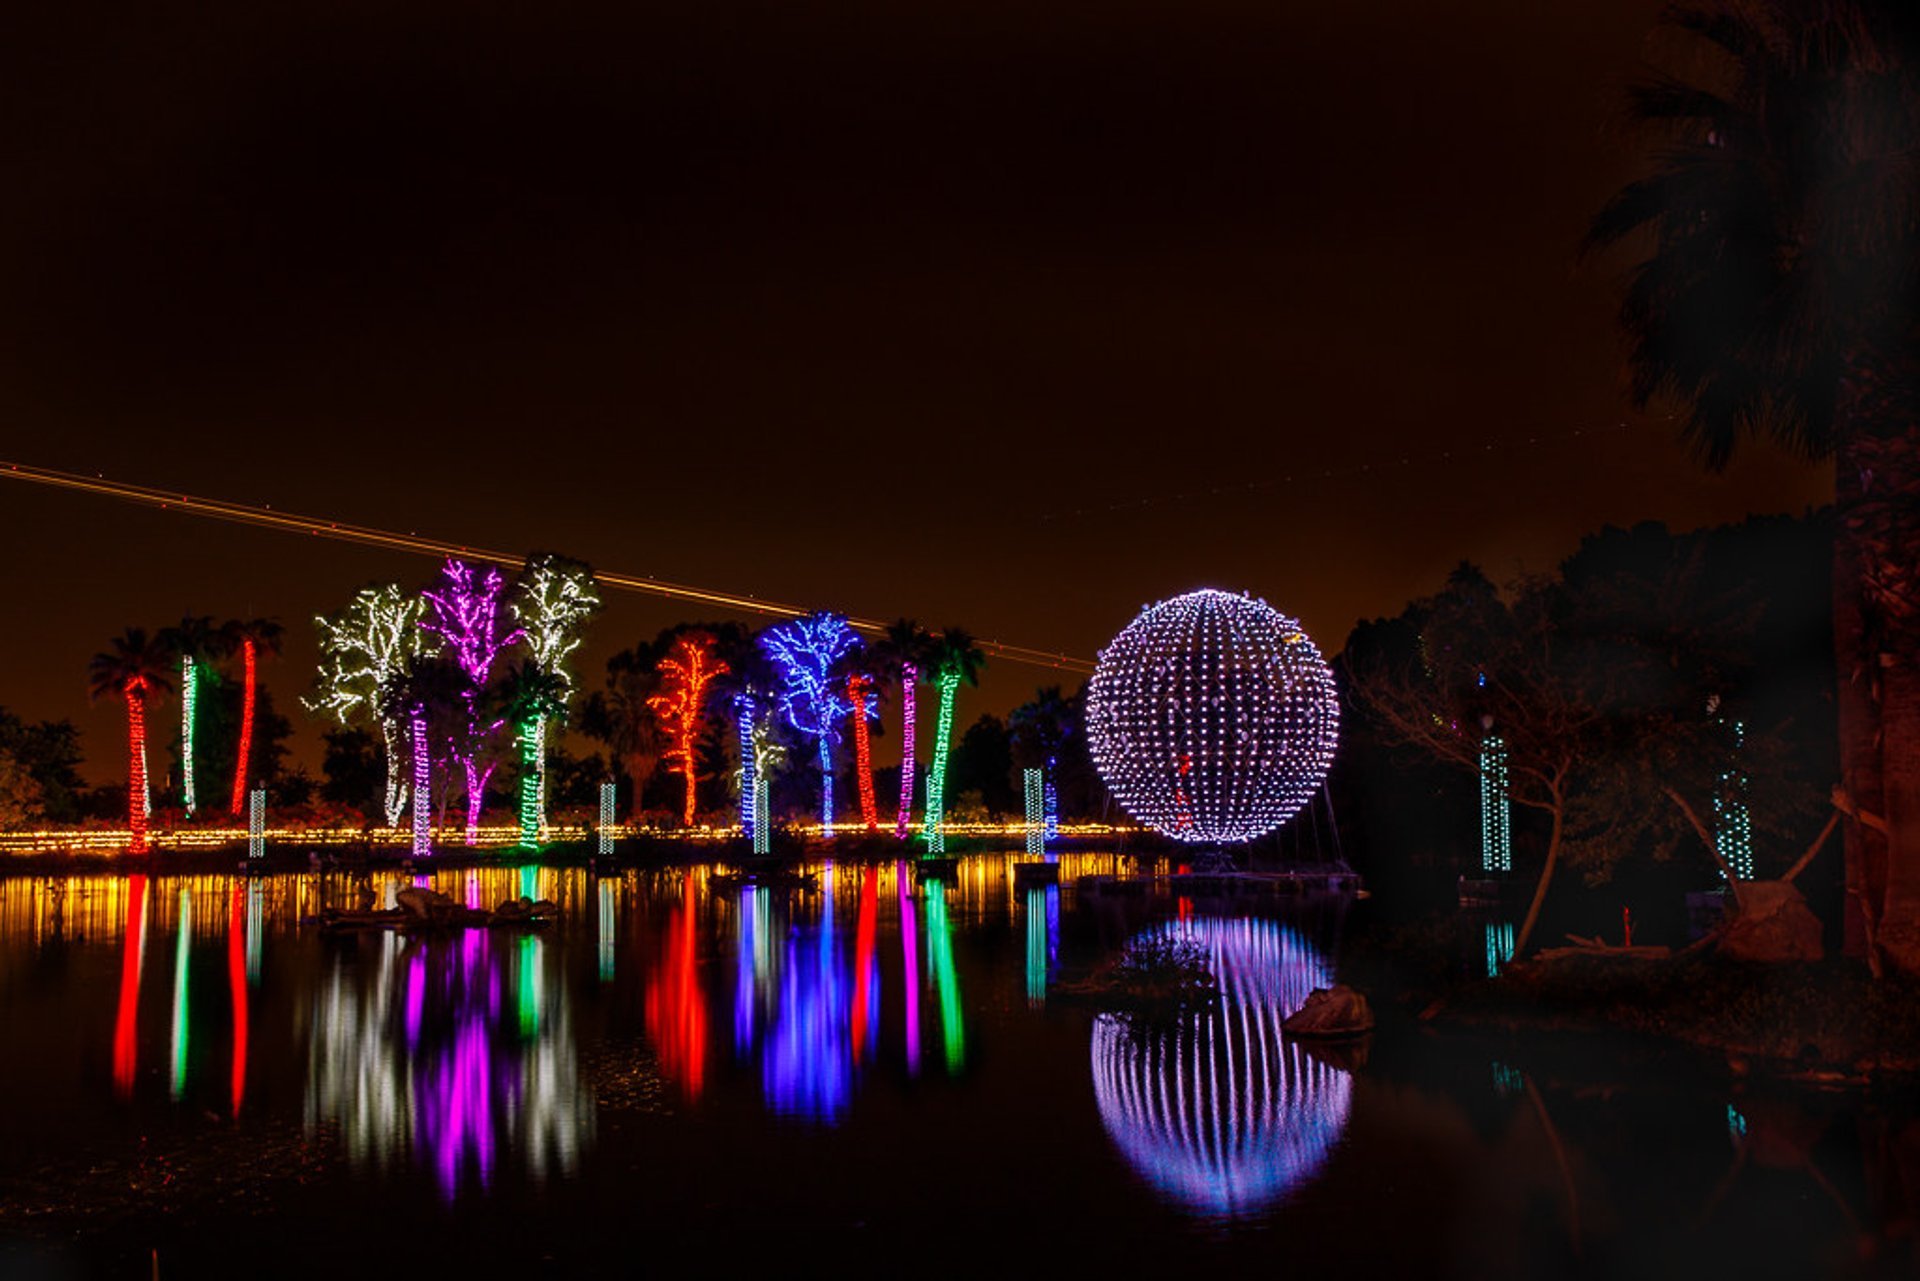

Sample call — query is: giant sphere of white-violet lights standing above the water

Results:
[1087,590,1340,845]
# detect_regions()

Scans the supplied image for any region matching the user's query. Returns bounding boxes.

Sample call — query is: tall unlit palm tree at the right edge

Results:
[1588,0,1920,974]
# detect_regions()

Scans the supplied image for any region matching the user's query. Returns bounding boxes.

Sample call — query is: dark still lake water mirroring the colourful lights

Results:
[0,855,1920,1277]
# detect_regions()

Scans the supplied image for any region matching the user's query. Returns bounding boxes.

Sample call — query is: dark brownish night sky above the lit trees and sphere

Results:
[0,0,1828,783]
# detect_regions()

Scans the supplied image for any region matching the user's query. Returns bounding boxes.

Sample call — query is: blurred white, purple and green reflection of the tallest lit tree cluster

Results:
[305,930,593,1198]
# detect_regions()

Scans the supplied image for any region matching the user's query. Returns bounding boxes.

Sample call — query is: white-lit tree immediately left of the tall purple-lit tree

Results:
[301,584,426,828]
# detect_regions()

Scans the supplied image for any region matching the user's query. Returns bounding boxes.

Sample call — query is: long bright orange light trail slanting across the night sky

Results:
[0,463,1092,676]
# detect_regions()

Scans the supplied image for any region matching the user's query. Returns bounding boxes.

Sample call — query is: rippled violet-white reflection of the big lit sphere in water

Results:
[1092,918,1352,1218]
